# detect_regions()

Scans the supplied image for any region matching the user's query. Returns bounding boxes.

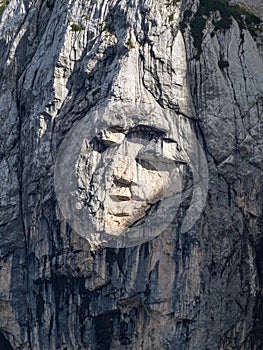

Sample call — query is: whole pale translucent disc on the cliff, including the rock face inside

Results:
[55,101,208,248]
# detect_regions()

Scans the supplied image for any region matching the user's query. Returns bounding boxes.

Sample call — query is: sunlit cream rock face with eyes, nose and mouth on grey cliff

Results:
[79,127,183,235]
